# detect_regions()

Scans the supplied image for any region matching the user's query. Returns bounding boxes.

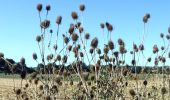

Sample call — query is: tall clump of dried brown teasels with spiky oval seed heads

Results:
[0,1,170,100]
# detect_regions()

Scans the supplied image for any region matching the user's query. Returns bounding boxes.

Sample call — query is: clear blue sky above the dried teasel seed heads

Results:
[0,0,170,66]
